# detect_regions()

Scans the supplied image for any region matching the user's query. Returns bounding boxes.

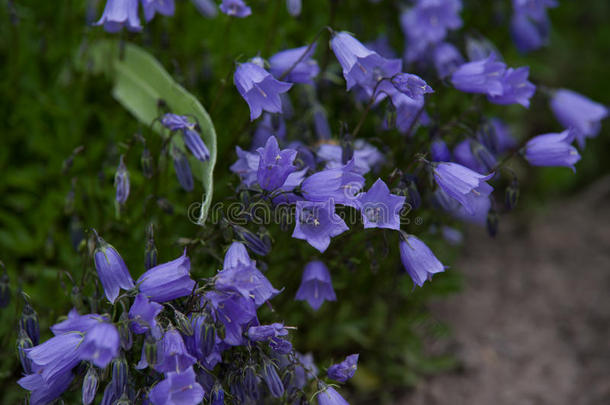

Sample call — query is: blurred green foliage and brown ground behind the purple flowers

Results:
[0,0,610,404]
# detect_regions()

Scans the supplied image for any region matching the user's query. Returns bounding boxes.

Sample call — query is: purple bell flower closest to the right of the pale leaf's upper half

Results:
[233,59,292,121]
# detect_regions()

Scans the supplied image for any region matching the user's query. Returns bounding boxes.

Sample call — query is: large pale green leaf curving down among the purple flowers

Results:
[80,40,216,225]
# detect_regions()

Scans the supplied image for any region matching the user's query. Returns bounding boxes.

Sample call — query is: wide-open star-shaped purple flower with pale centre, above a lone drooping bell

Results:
[292,200,349,253]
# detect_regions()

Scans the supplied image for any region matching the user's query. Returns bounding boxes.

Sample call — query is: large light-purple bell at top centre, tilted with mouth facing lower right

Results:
[330,32,402,97]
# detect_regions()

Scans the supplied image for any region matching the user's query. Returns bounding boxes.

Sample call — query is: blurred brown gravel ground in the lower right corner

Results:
[401,177,610,405]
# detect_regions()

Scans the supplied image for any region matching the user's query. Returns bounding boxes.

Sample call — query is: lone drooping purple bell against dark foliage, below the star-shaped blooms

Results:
[295,260,337,311]
